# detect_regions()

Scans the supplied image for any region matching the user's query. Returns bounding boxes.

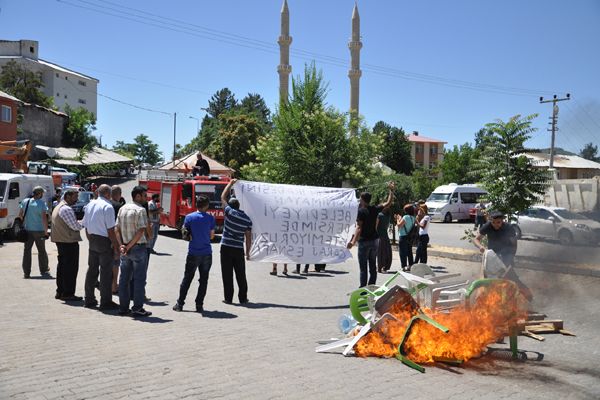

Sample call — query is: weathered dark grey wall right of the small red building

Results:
[17,104,68,152]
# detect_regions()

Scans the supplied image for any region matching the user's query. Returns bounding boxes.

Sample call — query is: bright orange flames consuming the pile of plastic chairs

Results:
[354,281,526,363]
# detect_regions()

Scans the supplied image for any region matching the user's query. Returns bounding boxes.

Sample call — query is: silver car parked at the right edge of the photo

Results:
[513,206,600,245]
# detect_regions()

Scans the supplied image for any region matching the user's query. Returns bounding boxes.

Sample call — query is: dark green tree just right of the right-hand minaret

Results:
[373,121,414,175]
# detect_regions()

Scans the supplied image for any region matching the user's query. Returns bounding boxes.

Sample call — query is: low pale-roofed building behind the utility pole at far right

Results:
[527,153,600,179]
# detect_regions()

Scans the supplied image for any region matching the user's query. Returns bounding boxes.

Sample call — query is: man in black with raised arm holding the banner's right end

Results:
[347,182,396,287]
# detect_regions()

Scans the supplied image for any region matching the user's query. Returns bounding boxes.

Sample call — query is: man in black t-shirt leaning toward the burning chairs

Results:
[473,210,532,301]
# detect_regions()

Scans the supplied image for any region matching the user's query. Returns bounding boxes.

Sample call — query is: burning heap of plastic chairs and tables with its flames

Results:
[316,269,523,372]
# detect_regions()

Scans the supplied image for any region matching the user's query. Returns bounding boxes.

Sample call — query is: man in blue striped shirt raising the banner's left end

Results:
[221,179,252,304]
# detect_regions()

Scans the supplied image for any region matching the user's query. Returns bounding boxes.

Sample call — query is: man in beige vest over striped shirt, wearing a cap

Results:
[50,189,83,301]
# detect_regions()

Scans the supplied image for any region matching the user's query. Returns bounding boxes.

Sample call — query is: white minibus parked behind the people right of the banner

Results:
[425,183,487,222]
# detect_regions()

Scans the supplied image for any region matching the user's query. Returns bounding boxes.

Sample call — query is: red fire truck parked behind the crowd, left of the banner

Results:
[139,170,230,233]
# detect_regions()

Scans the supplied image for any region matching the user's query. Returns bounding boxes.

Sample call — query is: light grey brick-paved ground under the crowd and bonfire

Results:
[0,225,600,400]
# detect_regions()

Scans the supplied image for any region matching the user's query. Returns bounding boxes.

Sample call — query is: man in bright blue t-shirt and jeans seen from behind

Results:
[173,196,215,313]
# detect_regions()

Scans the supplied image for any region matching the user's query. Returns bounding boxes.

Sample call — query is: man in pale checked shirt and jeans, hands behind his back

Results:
[115,186,152,317]
